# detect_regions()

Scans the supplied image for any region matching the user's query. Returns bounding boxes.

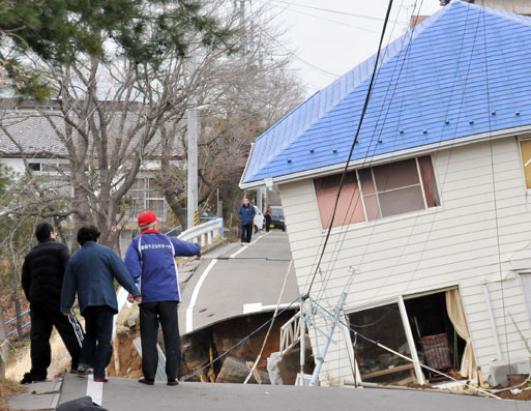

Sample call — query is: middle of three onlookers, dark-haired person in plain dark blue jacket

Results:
[61,226,142,382]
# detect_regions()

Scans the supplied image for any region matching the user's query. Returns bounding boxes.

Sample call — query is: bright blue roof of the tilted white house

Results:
[242,1,531,184]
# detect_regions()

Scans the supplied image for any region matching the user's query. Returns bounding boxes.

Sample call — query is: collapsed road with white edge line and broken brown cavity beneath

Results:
[108,231,313,384]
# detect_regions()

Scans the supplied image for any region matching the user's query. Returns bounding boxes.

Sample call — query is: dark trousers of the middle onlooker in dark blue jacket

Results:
[79,305,115,378]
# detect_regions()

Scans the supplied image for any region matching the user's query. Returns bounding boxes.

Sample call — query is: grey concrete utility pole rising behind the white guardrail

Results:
[186,55,199,228]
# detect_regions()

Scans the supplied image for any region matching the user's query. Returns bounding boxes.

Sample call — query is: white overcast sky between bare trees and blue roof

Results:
[253,0,440,94]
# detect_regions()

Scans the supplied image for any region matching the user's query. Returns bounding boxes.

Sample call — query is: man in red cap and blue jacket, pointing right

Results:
[125,211,201,386]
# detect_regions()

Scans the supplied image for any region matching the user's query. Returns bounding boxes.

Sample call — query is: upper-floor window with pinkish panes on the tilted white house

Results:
[314,156,440,228]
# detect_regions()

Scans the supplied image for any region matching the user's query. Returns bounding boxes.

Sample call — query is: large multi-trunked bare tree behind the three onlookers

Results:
[0,2,237,246]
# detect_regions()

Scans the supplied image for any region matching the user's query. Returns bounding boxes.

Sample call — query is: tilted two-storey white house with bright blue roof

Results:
[240,1,531,384]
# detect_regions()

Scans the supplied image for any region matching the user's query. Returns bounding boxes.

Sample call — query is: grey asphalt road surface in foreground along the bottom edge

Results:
[53,375,531,411]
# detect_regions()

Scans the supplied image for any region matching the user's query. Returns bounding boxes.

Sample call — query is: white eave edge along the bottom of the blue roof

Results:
[240,125,531,189]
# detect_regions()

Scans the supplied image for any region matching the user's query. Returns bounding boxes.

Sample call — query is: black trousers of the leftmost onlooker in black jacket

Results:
[30,303,83,380]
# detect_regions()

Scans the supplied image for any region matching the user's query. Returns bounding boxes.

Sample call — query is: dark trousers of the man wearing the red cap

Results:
[140,301,181,380]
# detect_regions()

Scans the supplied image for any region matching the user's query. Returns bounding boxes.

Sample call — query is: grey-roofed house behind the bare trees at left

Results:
[0,101,170,228]
